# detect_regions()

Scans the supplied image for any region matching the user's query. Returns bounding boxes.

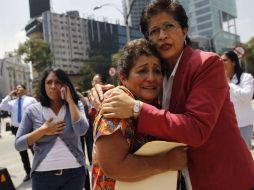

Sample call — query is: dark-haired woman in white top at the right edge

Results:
[221,51,254,148]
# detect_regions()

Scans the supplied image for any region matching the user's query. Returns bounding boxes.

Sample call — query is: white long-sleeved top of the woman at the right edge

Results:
[229,73,254,127]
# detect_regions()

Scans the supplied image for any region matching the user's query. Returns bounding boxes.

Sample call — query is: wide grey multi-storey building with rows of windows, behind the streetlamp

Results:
[42,11,141,74]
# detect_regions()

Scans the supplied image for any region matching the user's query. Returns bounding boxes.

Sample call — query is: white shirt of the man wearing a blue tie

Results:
[0,95,37,127]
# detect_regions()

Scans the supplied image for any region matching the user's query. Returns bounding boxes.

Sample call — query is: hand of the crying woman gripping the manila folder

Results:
[165,146,187,170]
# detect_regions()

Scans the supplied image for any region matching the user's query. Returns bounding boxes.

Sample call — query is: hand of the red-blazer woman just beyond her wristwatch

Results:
[101,90,134,119]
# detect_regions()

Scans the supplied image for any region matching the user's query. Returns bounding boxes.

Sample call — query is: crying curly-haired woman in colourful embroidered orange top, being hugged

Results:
[92,39,186,190]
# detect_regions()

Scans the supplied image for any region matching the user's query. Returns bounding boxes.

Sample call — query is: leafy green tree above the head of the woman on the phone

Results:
[15,39,53,73]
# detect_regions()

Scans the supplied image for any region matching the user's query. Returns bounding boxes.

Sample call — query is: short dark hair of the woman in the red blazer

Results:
[140,0,191,45]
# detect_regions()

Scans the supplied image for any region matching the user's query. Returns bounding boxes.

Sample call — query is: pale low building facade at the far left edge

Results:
[0,57,32,98]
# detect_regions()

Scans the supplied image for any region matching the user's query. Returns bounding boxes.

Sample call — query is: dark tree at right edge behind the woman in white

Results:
[244,37,254,76]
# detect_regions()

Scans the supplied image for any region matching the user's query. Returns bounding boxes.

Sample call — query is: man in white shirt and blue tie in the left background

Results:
[0,84,37,182]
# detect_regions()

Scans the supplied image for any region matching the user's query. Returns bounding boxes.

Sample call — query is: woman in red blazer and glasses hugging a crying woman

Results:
[93,0,254,190]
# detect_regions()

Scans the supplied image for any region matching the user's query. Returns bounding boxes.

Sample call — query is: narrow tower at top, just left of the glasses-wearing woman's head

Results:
[122,0,152,28]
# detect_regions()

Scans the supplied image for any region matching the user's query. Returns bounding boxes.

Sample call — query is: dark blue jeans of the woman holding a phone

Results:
[32,167,85,190]
